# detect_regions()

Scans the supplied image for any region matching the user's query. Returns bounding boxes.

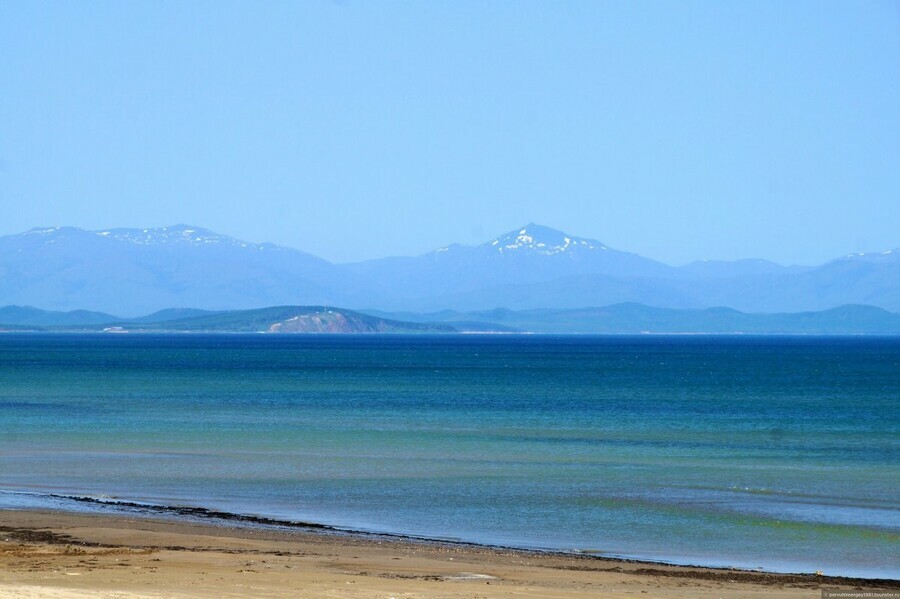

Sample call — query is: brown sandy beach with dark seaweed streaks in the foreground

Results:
[0,510,900,599]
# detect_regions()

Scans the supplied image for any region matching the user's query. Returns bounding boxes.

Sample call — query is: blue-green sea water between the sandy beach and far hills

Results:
[0,334,900,578]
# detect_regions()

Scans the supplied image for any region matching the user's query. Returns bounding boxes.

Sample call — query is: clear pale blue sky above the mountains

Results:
[0,0,900,264]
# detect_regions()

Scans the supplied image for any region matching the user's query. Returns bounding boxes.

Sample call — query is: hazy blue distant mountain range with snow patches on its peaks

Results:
[0,224,900,317]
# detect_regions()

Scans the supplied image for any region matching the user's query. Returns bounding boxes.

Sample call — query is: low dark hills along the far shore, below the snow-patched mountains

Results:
[0,304,900,335]
